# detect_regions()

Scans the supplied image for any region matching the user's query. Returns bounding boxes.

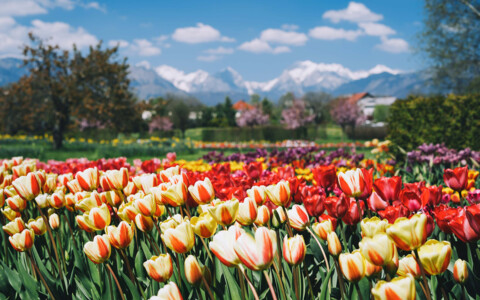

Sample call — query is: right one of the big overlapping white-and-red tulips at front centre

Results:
[234,227,277,271]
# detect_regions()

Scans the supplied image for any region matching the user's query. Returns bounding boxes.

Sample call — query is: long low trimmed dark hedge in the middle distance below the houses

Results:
[201,126,326,142]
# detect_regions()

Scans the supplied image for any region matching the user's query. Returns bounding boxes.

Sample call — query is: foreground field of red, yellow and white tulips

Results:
[0,143,480,300]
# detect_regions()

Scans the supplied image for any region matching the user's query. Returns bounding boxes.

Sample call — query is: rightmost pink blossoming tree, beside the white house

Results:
[330,98,365,136]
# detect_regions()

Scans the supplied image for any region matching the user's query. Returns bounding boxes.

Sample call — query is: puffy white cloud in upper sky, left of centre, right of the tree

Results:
[172,23,235,44]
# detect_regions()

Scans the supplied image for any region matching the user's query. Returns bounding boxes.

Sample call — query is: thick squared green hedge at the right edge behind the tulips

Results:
[387,94,480,150]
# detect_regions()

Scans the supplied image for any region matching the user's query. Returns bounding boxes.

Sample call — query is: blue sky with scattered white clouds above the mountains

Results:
[0,0,423,81]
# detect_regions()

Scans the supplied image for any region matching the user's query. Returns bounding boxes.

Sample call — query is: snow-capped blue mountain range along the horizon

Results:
[0,58,432,105]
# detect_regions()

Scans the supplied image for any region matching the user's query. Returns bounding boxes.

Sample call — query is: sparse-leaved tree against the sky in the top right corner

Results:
[419,0,480,92]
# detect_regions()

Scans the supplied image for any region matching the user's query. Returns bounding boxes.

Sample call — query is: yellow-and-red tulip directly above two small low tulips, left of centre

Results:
[162,221,195,253]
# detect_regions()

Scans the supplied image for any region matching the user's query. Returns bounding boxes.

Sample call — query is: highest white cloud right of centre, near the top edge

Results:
[322,1,383,23]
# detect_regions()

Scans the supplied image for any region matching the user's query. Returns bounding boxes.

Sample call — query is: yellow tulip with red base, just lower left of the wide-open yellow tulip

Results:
[359,233,395,266]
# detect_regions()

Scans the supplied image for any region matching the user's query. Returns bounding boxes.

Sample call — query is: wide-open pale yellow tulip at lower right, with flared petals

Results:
[387,214,427,251]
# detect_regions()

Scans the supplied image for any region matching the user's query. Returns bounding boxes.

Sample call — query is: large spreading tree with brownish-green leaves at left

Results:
[23,34,141,149]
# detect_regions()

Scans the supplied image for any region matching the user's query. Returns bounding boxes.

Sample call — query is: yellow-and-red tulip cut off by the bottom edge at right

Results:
[372,274,416,300]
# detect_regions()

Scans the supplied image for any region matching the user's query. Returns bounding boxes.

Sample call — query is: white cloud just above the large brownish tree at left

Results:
[31,20,98,48]
